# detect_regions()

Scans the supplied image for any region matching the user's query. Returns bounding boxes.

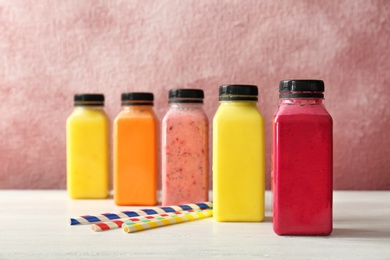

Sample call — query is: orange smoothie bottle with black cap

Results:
[114,92,158,206]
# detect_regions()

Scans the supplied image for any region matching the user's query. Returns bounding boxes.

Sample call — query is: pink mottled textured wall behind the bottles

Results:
[0,0,390,189]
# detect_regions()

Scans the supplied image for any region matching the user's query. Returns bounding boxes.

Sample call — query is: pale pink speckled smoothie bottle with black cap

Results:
[162,89,209,206]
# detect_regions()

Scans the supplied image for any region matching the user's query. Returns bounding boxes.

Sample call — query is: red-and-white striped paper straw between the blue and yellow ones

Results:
[91,210,194,232]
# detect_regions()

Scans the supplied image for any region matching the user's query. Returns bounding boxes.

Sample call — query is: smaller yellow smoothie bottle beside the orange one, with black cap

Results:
[66,94,109,199]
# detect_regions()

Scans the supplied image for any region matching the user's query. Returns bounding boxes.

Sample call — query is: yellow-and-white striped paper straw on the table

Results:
[122,209,213,233]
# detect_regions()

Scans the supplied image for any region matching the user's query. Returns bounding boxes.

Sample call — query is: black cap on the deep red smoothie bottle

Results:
[279,79,325,98]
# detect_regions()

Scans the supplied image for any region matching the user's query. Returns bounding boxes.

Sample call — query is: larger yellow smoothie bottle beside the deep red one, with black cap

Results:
[213,85,265,222]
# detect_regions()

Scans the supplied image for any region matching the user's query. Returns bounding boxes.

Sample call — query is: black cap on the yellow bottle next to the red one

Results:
[219,85,259,101]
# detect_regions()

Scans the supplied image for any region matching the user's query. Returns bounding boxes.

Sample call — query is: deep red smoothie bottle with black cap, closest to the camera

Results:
[272,80,333,236]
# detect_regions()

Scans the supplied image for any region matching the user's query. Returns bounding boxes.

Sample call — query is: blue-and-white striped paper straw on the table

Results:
[69,202,213,225]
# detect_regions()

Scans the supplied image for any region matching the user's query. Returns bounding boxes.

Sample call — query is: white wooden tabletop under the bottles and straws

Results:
[0,190,390,259]
